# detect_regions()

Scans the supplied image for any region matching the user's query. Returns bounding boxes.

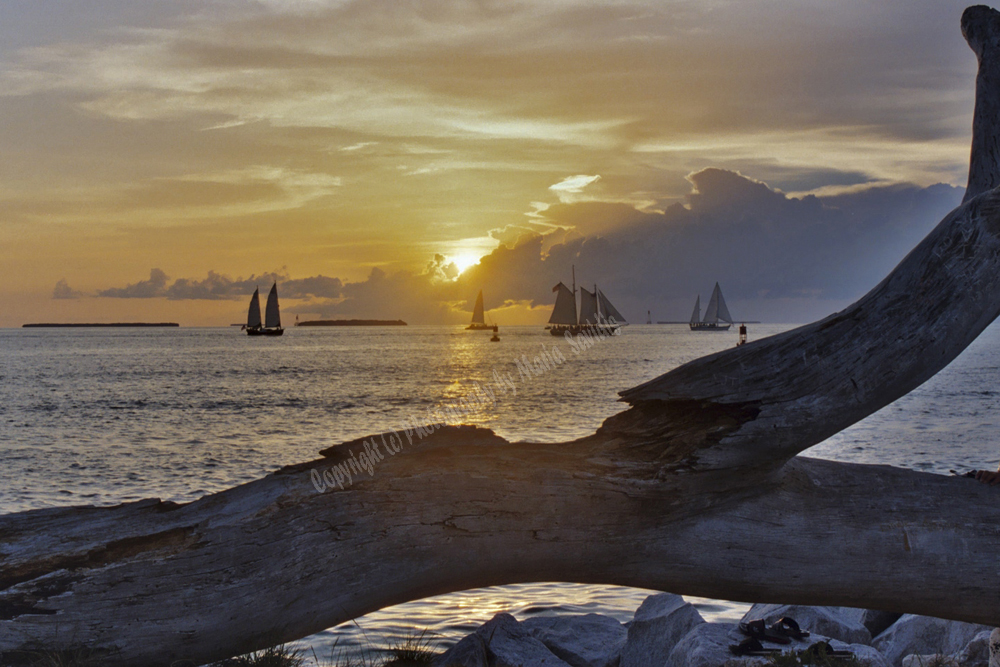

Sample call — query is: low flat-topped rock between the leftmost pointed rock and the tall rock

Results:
[521,614,628,667]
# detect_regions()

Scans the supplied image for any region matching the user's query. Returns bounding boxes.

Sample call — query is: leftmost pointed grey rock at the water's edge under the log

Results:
[432,613,570,667]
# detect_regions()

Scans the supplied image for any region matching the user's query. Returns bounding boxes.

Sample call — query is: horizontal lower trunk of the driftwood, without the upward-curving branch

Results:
[0,428,1000,665]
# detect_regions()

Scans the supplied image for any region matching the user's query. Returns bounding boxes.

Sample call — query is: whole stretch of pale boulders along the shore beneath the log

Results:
[433,593,1000,667]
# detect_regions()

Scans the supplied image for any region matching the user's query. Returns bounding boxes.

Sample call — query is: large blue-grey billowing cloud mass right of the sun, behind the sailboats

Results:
[456,169,962,322]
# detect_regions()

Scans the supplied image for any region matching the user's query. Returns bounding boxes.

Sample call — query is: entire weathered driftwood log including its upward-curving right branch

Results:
[0,7,1000,667]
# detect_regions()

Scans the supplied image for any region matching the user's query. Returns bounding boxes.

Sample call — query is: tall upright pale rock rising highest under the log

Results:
[620,593,705,667]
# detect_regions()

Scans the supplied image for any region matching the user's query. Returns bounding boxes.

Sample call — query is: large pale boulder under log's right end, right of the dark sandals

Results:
[872,614,991,667]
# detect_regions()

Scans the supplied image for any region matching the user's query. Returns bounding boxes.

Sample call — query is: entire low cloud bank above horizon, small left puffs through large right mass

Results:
[90,168,962,324]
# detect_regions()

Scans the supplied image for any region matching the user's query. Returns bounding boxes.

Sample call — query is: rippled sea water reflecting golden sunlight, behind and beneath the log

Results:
[0,325,1000,657]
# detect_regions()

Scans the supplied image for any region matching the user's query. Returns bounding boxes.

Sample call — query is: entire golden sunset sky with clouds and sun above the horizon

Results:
[0,0,976,327]
